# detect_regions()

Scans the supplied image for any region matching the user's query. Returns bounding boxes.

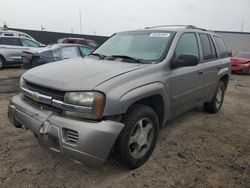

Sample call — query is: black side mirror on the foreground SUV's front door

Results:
[171,54,199,68]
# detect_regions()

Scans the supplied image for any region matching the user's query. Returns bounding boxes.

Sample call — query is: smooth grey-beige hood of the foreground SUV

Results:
[23,57,147,91]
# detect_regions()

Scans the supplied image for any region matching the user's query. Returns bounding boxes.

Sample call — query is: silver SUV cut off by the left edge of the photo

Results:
[0,36,44,69]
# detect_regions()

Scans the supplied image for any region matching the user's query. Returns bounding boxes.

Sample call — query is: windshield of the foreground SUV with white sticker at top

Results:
[93,31,173,61]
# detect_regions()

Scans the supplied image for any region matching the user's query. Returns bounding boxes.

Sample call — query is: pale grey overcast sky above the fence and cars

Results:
[0,0,250,35]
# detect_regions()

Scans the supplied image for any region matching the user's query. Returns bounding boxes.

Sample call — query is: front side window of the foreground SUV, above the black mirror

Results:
[174,33,200,59]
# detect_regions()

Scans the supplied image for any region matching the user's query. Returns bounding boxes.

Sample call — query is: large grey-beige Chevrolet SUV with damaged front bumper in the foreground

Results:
[8,26,231,169]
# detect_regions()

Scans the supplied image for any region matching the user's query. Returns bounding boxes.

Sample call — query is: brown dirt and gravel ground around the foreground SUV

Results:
[0,69,250,188]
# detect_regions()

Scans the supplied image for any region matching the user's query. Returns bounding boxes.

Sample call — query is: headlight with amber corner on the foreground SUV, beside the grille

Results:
[64,92,105,119]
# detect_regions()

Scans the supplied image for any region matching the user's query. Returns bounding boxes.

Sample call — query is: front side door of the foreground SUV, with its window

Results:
[170,32,205,115]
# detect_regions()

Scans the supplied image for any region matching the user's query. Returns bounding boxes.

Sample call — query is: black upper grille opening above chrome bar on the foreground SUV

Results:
[25,82,65,101]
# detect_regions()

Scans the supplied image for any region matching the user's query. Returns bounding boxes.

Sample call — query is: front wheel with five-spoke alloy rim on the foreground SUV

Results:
[115,104,159,169]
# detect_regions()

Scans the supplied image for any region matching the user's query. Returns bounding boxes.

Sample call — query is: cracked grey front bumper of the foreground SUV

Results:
[8,95,124,165]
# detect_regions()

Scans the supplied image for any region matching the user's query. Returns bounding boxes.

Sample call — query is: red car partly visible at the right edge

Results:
[230,52,250,74]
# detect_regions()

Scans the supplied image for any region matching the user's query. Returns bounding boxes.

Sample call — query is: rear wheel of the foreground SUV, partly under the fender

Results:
[204,81,226,114]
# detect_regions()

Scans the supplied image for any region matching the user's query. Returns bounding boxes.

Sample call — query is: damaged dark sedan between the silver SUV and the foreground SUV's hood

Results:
[22,44,93,69]
